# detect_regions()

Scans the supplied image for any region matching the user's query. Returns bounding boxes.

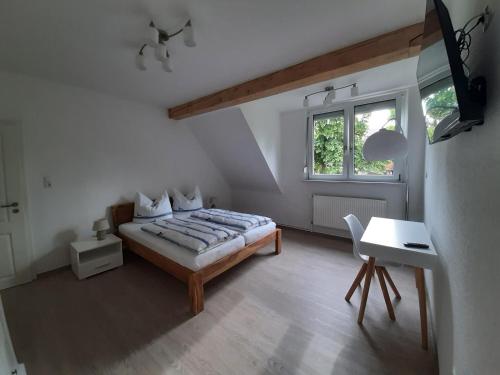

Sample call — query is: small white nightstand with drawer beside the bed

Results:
[71,234,123,280]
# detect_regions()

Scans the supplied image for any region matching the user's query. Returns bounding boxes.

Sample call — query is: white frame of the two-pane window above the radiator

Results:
[306,92,404,182]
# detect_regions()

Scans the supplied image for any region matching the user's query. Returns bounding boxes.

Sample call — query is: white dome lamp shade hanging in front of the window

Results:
[363,129,408,161]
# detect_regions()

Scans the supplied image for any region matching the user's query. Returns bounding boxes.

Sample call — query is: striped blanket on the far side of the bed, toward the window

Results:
[191,208,272,232]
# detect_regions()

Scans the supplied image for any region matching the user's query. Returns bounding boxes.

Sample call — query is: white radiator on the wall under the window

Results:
[313,195,387,230]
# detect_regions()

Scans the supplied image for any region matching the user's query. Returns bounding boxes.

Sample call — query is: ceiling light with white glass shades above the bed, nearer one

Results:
[135,20,196,72]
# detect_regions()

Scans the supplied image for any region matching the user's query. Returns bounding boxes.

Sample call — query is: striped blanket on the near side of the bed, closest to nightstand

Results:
[141,218,239,254]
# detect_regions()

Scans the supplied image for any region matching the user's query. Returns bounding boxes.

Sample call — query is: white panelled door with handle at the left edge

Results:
[0,122,32,289]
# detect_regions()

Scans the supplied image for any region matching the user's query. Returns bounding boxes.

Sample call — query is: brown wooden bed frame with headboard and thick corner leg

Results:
[111,203,281,315]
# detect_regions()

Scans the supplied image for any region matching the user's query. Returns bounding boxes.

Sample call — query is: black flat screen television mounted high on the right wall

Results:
[417,0,485,143]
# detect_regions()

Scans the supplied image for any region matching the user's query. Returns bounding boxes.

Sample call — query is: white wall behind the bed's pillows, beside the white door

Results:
[0,73,231,273]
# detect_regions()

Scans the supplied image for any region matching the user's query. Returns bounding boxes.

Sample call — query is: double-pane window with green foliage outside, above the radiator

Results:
[307,95,401,180]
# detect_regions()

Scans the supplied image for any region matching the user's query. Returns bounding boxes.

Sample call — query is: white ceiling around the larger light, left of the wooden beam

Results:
[0,0,425,107]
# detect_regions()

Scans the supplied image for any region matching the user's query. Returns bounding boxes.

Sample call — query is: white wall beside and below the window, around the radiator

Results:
[233,88,425,235]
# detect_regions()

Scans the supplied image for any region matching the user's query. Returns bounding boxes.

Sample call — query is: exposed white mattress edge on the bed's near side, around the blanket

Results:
[118,223,245,271]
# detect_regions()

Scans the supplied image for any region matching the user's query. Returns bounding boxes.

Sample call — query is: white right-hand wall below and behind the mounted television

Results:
[425,0,500,375]
